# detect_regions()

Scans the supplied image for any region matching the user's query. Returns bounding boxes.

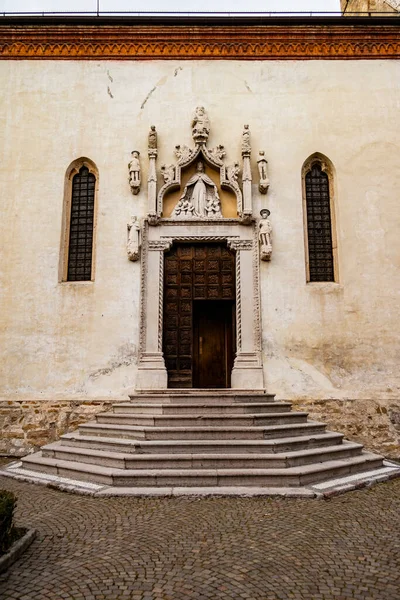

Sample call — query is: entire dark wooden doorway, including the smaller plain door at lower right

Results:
[163,244,236,388]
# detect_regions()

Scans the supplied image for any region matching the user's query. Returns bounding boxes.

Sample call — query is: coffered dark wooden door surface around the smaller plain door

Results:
[163,244,235,388]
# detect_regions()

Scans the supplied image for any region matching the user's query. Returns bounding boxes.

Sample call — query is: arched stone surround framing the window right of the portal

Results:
[301,152,339,283]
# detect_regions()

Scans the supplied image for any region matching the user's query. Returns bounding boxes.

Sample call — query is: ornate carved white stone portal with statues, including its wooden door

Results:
[131,106,264,390]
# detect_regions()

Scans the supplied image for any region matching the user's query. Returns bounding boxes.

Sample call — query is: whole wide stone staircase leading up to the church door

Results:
[10,390,394,495]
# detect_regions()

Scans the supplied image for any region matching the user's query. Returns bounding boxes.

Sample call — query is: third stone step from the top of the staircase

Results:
[96,412,308,429]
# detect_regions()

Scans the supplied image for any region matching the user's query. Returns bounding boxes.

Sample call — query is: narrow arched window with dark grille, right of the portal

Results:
[302,153,337,282]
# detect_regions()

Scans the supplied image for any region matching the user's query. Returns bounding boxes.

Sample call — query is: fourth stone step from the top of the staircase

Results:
[79,422,325,440]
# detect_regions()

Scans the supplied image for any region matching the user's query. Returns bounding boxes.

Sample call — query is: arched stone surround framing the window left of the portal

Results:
[58,156,99,283]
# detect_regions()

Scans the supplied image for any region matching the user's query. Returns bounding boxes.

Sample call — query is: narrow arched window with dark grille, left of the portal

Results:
[61,158,98,281]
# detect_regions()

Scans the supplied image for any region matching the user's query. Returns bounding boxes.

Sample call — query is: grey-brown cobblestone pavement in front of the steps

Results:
[0,477,400,600]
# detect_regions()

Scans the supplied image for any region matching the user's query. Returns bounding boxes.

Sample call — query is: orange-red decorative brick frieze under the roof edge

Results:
[0,24,400,60]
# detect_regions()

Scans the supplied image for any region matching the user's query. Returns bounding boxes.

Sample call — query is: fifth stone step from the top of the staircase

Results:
[60,431,343,454]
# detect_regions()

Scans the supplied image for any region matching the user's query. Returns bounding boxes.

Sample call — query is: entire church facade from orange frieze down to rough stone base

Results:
[0,12,400,457]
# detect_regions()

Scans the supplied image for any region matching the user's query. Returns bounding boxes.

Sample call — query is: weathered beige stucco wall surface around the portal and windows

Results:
[0,60,400,412]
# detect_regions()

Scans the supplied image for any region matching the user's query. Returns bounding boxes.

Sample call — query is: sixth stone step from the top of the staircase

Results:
[42,442,362,469]
